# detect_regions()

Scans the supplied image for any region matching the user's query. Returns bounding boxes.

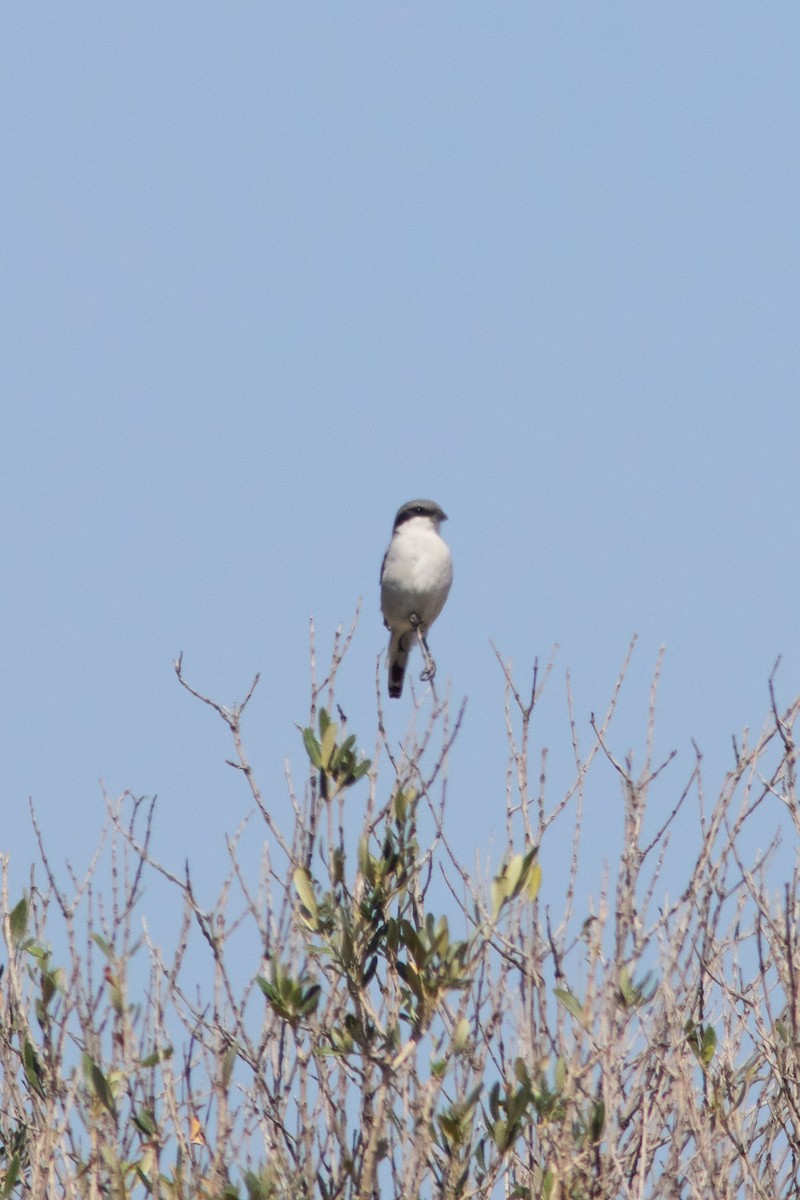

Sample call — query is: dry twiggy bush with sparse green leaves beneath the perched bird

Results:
[0,638,800,1200]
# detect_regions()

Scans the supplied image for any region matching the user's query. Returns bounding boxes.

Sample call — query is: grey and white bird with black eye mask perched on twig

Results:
[380,500,452,700]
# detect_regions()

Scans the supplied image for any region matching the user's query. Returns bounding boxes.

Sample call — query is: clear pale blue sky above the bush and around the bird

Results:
[0,0,800,916]
